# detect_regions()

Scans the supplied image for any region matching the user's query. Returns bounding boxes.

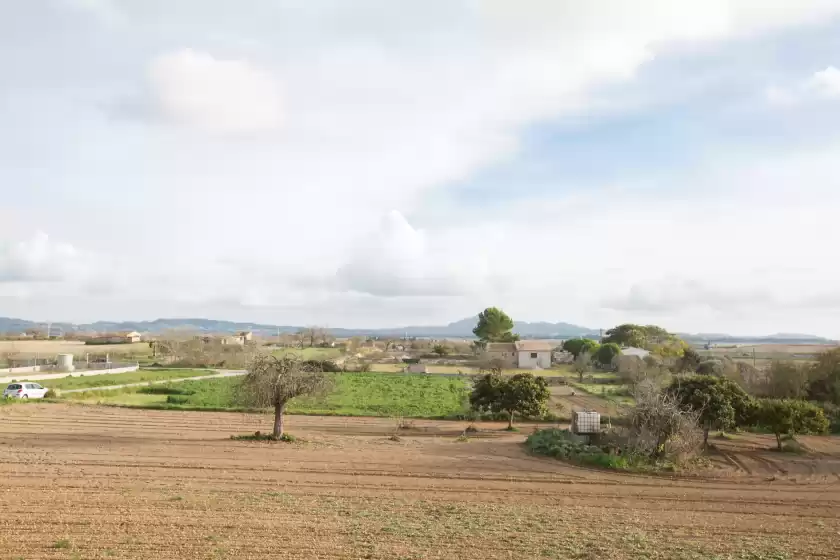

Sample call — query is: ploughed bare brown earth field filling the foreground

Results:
[0,404,840,559]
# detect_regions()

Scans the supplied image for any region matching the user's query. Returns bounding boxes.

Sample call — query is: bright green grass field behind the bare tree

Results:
[67,373,470,418]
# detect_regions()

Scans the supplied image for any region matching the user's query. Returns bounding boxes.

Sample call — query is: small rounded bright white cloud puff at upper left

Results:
[149,49,282,133]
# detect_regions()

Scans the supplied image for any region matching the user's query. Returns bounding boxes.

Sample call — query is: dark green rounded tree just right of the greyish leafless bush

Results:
[668,375,752,447]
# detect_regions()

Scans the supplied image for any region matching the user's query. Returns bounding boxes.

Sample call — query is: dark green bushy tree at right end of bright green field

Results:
[470,373,550,429]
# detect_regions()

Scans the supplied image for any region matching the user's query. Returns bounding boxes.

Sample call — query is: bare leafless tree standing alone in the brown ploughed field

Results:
[239,354,330,438]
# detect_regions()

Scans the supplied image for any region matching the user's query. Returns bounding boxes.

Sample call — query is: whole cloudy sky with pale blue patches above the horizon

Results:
[0,0,840,338]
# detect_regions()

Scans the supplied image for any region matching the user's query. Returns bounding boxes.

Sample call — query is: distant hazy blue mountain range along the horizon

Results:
[0,317,833,344]
